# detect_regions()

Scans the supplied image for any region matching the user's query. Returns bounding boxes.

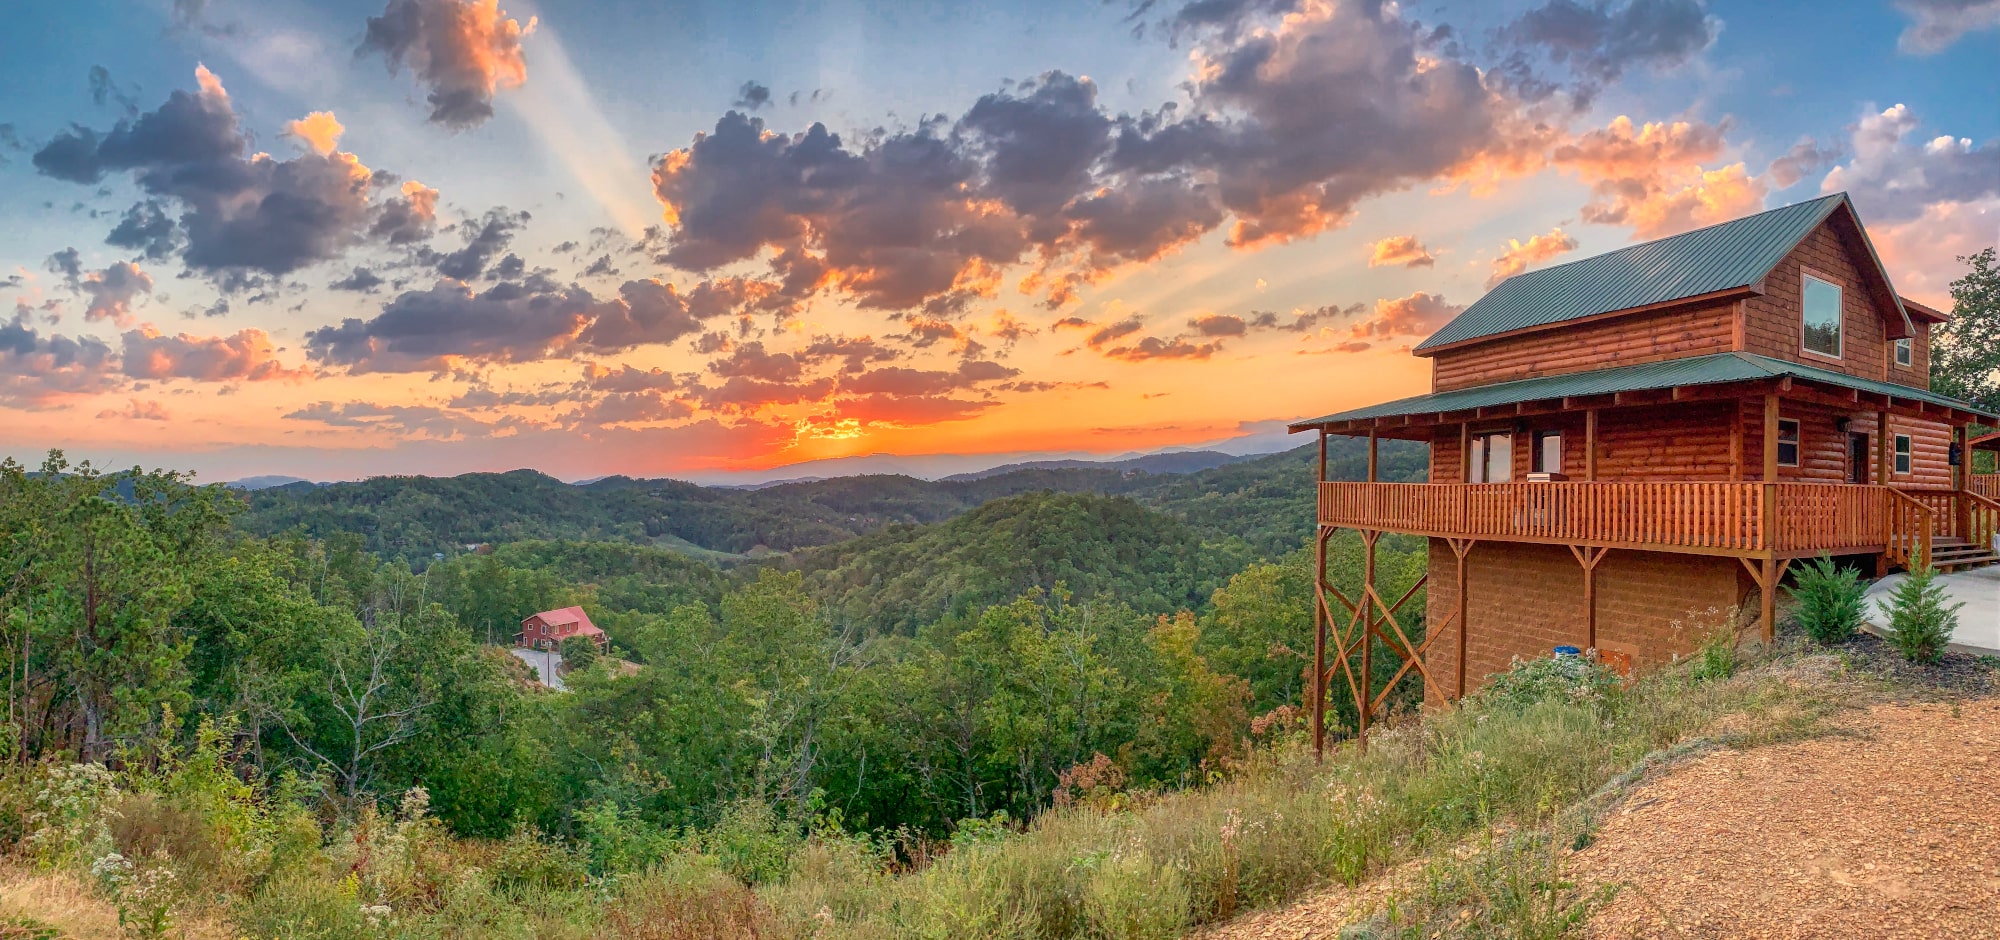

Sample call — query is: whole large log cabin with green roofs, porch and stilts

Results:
[1290,194,2000,746]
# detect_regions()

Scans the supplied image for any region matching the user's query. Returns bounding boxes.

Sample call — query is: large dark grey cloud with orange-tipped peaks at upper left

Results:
[34,66,418,288]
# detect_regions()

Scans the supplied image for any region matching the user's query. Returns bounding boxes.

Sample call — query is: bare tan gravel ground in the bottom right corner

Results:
[1572,700,2000,938]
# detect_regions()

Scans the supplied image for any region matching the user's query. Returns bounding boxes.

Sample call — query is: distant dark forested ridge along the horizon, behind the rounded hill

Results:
[236,438,1424,564]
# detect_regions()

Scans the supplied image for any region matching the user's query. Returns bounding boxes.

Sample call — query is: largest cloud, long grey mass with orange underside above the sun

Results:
[652,0,1554,316]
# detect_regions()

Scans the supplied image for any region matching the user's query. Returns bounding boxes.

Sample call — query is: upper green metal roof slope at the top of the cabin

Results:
[1416,192,1848,352]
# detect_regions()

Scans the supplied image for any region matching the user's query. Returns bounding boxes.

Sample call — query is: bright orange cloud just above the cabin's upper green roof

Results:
[1550,114,1770,238]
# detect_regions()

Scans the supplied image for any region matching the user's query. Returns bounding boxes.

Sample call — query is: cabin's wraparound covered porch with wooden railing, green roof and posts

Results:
[1290,352,2000,756]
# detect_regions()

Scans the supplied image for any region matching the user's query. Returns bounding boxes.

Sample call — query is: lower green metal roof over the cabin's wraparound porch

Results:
[1290,352,1996,432]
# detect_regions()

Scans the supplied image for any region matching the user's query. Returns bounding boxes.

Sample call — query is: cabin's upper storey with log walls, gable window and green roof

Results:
[1416,194,1944,392]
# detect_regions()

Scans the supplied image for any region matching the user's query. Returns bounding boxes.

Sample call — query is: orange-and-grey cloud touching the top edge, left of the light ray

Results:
[356,0,534,130]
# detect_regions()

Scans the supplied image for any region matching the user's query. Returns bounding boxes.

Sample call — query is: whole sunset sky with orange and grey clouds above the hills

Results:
[0,0,2000,480]
